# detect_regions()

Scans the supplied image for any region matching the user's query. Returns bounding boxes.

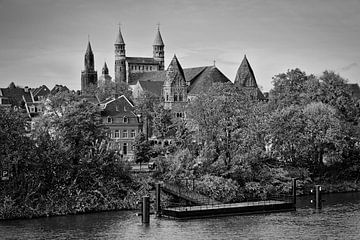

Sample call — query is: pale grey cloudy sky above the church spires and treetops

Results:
[0,0,360,91]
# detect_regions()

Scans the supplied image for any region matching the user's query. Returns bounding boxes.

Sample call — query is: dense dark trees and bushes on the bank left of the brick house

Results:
[0,94,132,218]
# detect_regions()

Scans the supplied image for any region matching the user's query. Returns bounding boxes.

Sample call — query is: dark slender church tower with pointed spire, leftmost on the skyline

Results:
[81,41,97,93]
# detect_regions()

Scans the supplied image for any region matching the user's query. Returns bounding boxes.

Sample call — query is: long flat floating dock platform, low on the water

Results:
[162,200,296,219]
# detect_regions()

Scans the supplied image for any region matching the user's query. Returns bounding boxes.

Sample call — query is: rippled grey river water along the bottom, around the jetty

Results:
[0,193,360,240]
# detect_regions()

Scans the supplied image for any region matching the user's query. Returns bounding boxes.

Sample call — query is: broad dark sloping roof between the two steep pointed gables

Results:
[188,66,230,95]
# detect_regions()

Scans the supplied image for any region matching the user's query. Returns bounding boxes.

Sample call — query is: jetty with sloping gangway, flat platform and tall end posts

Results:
[156,179,296,219]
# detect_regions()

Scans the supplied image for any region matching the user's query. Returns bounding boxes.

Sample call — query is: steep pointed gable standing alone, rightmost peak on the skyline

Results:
[234,55,257,88]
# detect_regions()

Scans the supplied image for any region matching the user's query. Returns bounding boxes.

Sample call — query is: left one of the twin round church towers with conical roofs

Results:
[114,26,126,84]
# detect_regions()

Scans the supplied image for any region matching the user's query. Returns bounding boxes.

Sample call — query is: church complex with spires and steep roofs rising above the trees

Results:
[81,27,265,111]
